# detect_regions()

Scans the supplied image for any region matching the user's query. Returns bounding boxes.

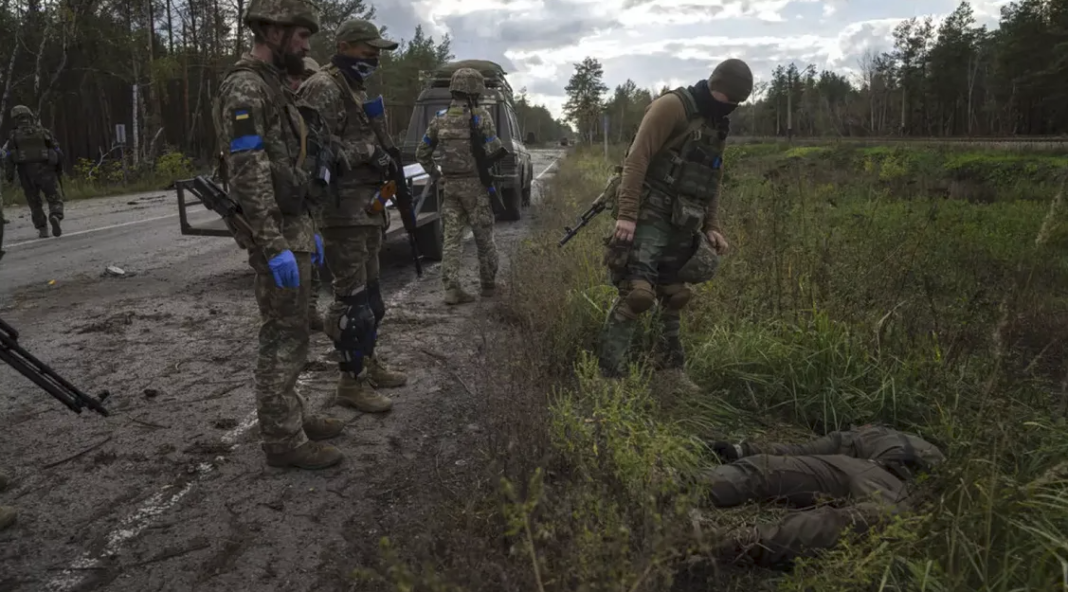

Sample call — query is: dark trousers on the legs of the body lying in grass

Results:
[706,454,907,566]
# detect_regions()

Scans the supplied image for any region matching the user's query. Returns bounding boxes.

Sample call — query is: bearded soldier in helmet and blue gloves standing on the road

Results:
[214,0,344,469]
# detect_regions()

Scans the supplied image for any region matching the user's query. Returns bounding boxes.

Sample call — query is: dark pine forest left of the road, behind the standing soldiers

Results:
[0,0,551,176]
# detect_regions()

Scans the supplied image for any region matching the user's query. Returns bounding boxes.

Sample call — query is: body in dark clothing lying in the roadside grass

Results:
[706,425,945,566]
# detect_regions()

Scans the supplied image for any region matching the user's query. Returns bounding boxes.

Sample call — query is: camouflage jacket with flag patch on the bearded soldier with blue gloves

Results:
[213,50,315,253]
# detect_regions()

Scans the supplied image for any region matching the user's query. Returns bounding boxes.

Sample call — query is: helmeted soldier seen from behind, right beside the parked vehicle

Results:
[415,67,501,305]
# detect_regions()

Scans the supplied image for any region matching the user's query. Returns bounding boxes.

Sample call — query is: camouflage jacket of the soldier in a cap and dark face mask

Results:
[299,65,386,228]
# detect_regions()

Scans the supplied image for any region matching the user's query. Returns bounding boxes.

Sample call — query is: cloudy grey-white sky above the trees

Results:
[372,0,1007,116]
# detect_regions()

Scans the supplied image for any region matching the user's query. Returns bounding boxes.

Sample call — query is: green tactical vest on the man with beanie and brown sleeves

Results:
[644,88,729,230]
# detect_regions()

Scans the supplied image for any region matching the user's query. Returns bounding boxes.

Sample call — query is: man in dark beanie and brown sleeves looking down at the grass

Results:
[600,59,753,392]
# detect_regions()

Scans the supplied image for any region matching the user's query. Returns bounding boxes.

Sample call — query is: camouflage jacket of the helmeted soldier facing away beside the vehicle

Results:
[415,99,501,177]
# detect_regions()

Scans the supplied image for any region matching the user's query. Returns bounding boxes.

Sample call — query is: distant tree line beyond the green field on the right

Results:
[565,0,1068,141]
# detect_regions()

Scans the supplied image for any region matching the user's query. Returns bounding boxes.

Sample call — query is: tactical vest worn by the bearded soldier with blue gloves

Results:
[213,58,311,216]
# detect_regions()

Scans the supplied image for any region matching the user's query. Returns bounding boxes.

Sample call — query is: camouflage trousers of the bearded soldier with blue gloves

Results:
[249,250,312,454]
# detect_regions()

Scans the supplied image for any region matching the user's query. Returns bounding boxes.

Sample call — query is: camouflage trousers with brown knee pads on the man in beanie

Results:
[600,219,693,374]
